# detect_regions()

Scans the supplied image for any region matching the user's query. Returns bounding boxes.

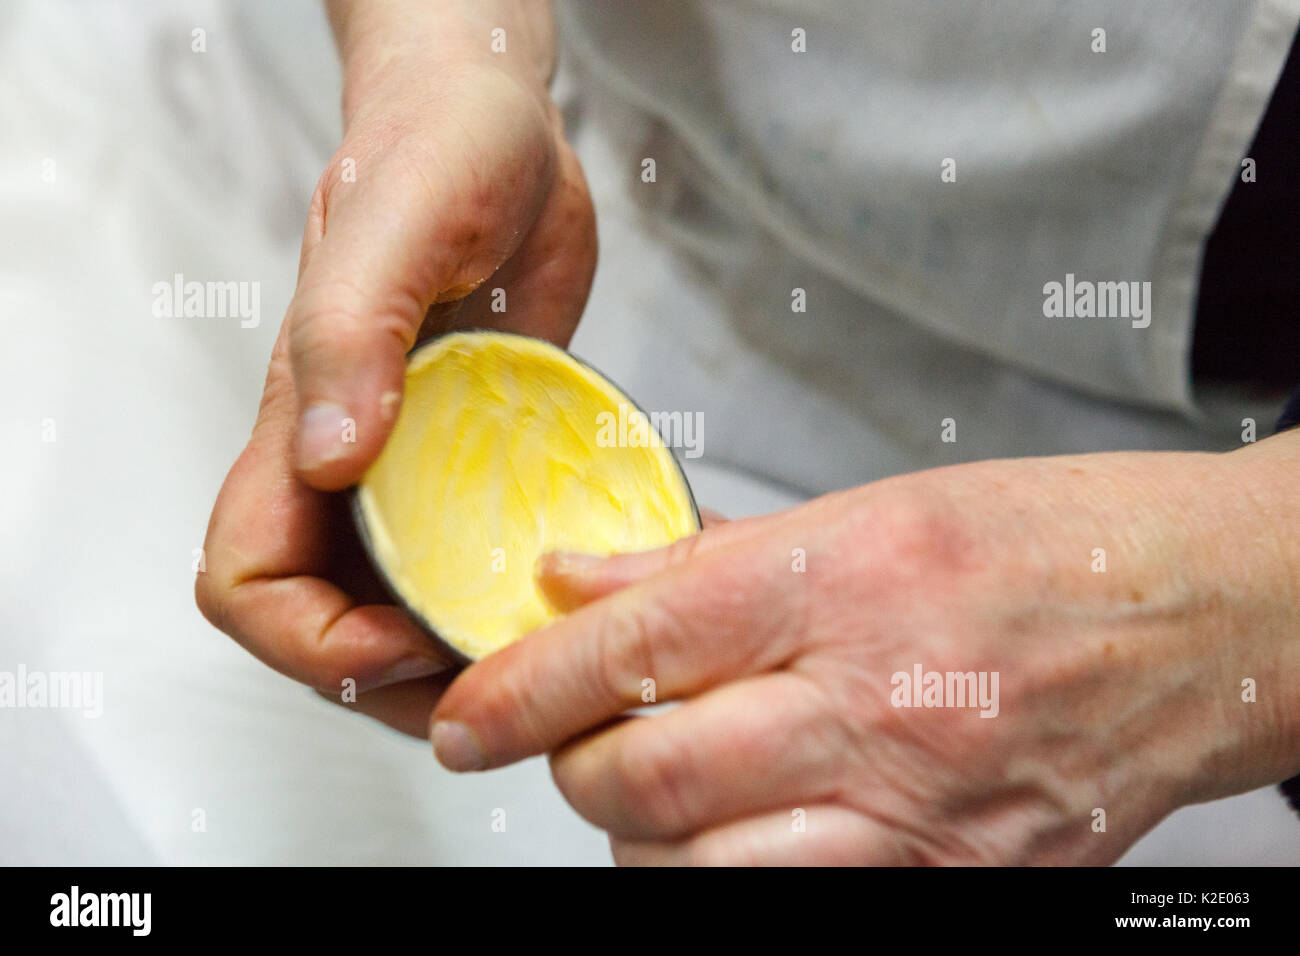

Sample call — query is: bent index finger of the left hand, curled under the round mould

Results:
[195,329,450,691]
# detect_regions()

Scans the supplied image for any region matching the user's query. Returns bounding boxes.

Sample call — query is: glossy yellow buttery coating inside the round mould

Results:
[359,332,699,659]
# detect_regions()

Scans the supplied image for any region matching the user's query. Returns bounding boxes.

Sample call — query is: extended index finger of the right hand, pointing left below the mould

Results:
[433,520,809,770]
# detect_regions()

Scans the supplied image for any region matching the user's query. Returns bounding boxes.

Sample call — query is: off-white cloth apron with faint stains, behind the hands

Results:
[560,0,1300,492]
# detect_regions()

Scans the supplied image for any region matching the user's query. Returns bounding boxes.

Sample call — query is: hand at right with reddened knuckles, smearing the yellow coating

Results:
[433,436,1300,864]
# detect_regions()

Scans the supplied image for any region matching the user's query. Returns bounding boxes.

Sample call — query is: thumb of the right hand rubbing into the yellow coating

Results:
[537,512,785,613]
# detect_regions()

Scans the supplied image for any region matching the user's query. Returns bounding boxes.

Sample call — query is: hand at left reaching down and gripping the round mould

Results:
[196,0,595,736]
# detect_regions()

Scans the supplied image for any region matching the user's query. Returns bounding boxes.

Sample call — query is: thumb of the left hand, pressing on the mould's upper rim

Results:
[287,156,543,490]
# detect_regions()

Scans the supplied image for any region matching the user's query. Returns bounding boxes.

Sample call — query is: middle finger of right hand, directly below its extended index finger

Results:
[551,671,849,840]
